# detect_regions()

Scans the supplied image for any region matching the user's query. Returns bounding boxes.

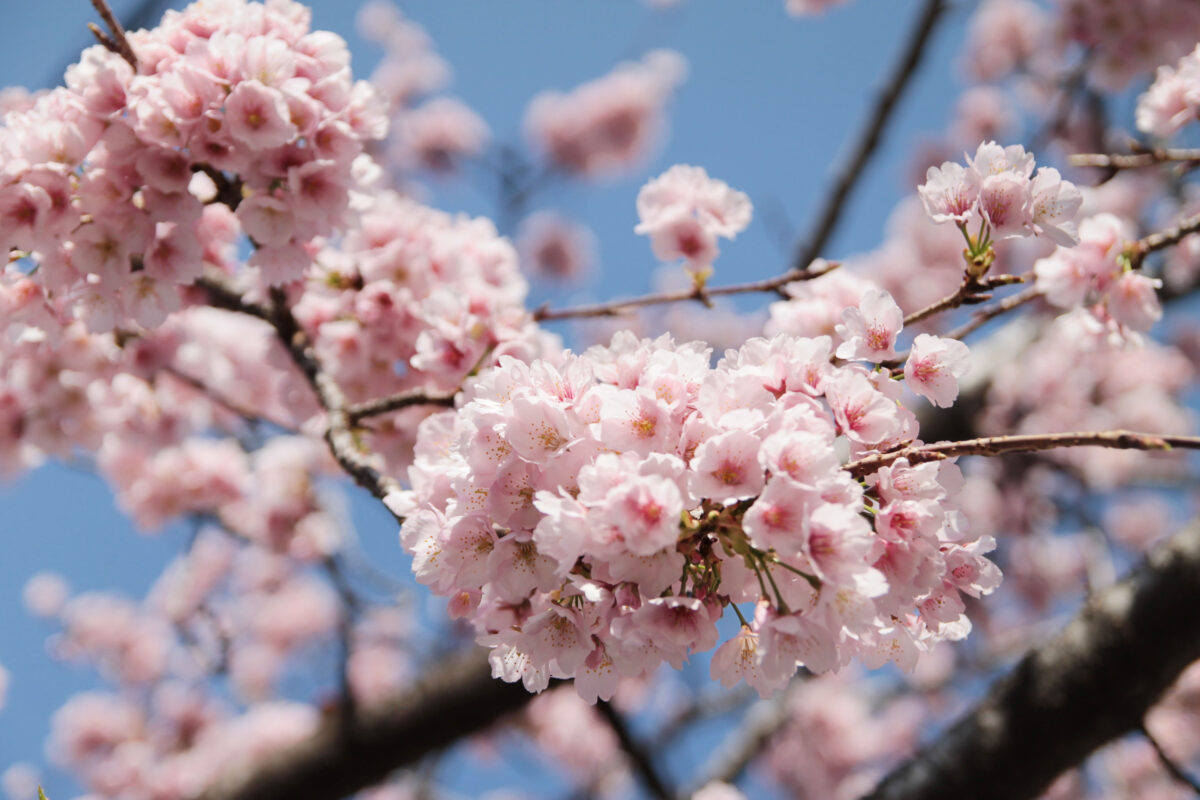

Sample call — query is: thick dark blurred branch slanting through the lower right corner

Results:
[869,522,1200,800]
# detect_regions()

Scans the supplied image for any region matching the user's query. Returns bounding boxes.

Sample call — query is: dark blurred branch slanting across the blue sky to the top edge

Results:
[792,0,946,271]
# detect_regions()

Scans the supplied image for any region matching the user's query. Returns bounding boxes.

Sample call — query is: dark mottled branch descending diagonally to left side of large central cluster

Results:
[196,277,403,522]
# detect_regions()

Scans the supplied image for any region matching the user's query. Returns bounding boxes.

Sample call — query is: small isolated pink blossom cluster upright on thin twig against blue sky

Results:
[634,164,752,271]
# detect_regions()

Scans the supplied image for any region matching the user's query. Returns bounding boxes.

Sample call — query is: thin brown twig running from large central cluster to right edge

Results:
[842,431,1200,477]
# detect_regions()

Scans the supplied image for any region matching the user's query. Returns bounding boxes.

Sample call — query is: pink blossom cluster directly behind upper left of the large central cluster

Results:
[294,191,559,471]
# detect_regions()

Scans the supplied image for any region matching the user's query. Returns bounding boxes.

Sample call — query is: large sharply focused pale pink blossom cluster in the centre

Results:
[389,335,998,700]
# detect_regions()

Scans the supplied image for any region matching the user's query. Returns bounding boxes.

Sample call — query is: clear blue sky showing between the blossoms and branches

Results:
[0,0,973,798]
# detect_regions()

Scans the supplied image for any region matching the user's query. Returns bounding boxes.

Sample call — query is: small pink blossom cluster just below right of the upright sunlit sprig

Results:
[1033,213,1163,331]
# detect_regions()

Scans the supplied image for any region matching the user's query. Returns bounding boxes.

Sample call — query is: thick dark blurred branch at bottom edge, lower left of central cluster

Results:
[199,650,544,800]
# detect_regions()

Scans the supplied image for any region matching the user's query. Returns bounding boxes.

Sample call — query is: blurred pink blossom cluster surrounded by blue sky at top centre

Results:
[526,50,686,176]
